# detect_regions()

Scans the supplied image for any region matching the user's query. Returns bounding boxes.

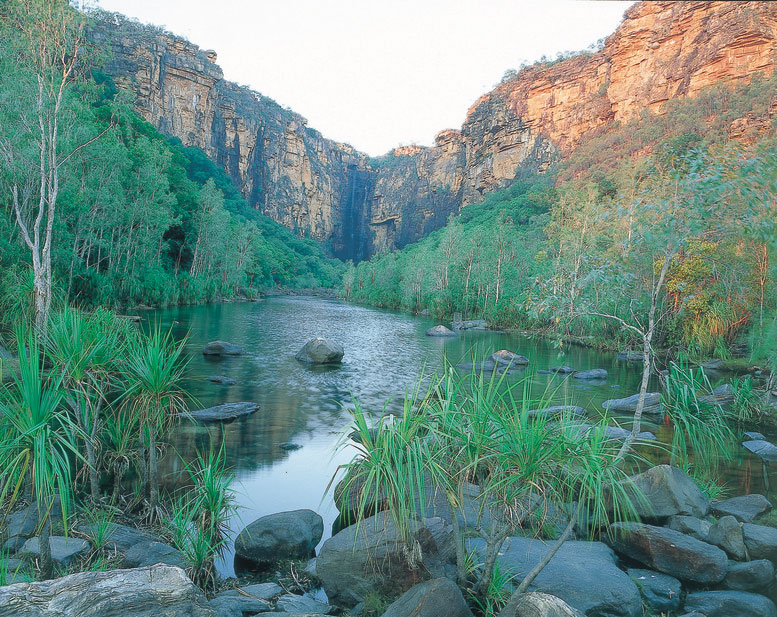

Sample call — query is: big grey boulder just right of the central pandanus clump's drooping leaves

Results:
[626,465,709,519]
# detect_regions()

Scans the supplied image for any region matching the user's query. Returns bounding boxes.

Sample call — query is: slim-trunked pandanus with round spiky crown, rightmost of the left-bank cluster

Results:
[124,324,187,518]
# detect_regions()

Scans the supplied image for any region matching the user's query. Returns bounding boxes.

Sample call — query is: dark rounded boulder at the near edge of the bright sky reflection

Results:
[235,510,324,565]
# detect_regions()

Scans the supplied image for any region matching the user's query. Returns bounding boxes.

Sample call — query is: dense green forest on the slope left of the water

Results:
[0,3,342,319]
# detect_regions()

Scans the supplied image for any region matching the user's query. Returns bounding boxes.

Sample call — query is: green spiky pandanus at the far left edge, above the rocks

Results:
[0,330,82,578]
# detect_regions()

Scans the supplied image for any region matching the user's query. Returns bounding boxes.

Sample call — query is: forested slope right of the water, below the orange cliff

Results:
[342,78,777,358]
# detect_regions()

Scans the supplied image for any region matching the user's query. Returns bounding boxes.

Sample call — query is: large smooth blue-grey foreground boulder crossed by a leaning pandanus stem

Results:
[467,537,642,617]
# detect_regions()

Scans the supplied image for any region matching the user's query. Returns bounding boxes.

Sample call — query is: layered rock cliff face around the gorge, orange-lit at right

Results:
[95,2,777,259]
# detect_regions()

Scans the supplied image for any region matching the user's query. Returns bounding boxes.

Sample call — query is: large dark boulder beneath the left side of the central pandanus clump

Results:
[316,512,455,607]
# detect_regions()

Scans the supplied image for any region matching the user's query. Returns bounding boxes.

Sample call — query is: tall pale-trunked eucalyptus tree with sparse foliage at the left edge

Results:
[0,0,107,331]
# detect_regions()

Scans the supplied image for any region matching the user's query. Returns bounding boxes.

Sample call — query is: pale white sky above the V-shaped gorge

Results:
[94,0,633,155]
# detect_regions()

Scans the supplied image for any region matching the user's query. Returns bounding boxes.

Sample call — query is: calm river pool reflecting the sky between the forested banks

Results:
[144,297,777,575]
